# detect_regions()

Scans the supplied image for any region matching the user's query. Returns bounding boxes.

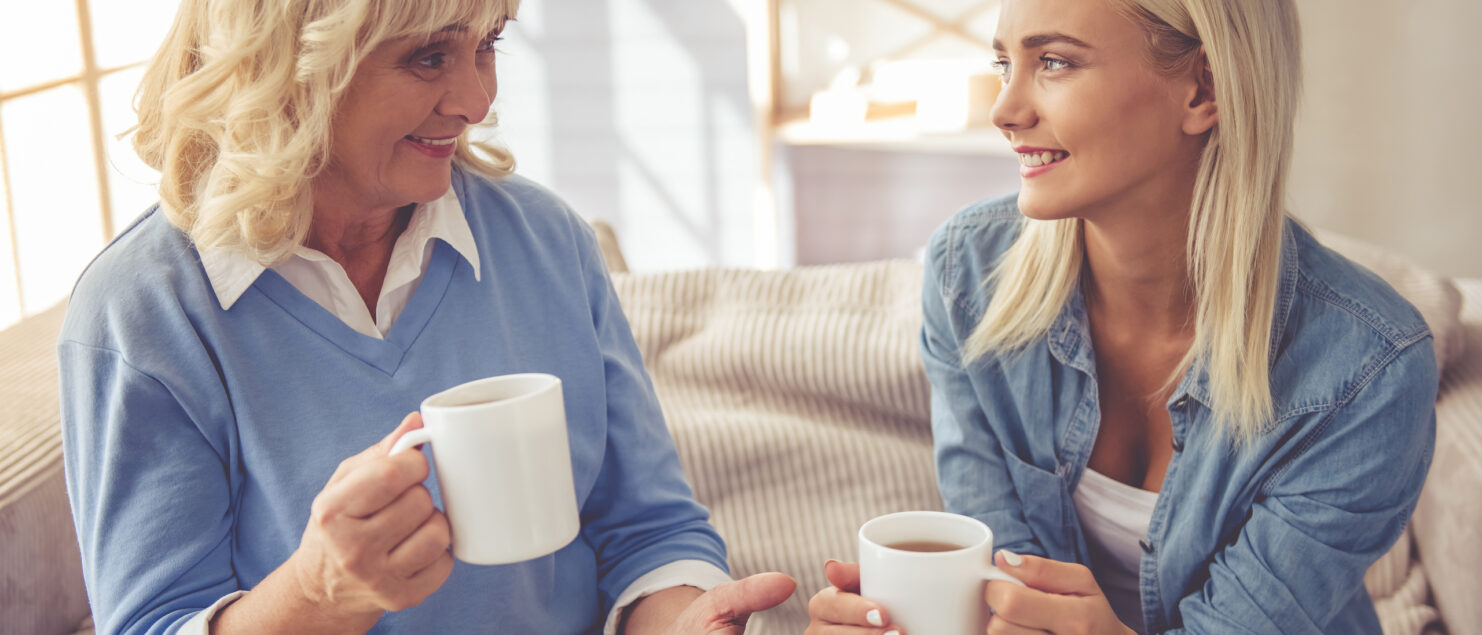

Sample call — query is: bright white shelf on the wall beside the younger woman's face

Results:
[777,117,1014,157]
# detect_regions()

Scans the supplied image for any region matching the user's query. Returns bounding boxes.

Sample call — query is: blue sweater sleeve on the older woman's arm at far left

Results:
[58,340,239,634]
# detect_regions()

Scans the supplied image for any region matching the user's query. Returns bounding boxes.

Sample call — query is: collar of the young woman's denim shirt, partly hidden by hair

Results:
[1048,221,1297,408]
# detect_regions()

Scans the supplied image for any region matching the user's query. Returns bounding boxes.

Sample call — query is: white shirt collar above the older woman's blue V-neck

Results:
[200,187,482,310]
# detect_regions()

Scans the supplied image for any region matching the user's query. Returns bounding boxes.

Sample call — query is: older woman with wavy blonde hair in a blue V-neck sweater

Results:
[58,0,793,634]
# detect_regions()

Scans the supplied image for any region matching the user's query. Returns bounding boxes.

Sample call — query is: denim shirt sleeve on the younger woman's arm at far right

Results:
[1177,337,1438,634]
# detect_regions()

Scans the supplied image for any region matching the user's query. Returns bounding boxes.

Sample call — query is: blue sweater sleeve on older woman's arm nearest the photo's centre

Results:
[575,220,728,611]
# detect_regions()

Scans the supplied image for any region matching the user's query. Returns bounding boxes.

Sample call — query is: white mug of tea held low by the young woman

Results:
[860,512,1024,635]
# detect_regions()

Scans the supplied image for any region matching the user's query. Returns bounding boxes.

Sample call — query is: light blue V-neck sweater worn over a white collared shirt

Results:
[58,172,725,634]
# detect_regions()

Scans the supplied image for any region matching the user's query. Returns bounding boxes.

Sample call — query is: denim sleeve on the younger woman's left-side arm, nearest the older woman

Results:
[920,234,1046,556]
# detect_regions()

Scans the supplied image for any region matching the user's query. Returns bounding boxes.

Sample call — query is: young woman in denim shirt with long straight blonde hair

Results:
[809,0,1438,635]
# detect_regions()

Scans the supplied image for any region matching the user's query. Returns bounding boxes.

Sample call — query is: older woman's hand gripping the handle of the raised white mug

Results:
[289,412,453,619]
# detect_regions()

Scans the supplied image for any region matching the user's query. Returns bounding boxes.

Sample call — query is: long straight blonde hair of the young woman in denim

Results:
[965,0,1301,444]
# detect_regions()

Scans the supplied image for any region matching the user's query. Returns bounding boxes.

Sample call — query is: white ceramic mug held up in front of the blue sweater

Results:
[391,374,581,564]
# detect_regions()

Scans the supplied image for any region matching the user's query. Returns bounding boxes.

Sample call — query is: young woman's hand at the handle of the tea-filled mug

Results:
[987,550,1132,635]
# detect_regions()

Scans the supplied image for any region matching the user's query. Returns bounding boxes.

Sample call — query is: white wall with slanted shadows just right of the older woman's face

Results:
[483,0,757,270]
